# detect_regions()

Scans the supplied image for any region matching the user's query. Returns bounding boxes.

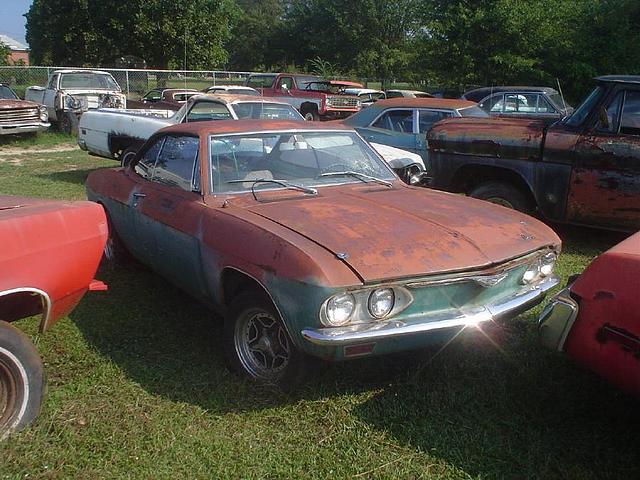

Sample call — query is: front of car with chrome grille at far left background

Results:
[0,83,51,135]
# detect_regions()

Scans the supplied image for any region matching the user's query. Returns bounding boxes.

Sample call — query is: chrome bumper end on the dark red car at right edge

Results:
[538,288,578,352]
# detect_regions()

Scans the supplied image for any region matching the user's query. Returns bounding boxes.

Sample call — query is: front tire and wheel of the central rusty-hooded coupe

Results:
[223,290,309,389]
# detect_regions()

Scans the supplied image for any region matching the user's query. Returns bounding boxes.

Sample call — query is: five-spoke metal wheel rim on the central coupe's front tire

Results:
[235,311,291,381]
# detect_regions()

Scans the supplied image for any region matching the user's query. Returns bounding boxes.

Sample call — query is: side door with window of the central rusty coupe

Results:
[137,134,207,297]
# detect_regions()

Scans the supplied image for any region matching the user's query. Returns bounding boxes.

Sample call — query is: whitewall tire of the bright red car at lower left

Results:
[0,321,44,440]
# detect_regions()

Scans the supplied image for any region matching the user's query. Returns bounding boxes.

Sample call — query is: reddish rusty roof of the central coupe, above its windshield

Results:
[158,119,353,135]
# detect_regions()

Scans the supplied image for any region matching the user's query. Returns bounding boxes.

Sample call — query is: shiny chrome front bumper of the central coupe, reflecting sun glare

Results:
[301,277,559,347]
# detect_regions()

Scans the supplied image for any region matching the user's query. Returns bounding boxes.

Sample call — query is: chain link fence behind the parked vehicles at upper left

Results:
[0,66,260,99]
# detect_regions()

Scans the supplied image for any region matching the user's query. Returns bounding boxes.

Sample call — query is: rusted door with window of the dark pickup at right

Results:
[567,86,640,230]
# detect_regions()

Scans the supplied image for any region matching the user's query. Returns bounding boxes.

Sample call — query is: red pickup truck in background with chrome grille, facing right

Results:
[245,73,362,120]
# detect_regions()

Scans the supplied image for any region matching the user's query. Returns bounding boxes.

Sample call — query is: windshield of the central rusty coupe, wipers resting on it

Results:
[210,131,395,193]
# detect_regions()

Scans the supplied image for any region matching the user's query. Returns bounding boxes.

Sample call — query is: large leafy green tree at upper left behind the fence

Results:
[25,0,237,69]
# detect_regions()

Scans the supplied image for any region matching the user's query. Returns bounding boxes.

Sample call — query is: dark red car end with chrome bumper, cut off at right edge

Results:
[540,233,640,397]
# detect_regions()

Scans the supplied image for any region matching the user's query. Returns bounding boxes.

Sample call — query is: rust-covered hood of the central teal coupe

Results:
[221,184,560,283]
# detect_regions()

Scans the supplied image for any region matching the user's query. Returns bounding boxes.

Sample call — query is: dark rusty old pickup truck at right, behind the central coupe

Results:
[427,76,640,231]
